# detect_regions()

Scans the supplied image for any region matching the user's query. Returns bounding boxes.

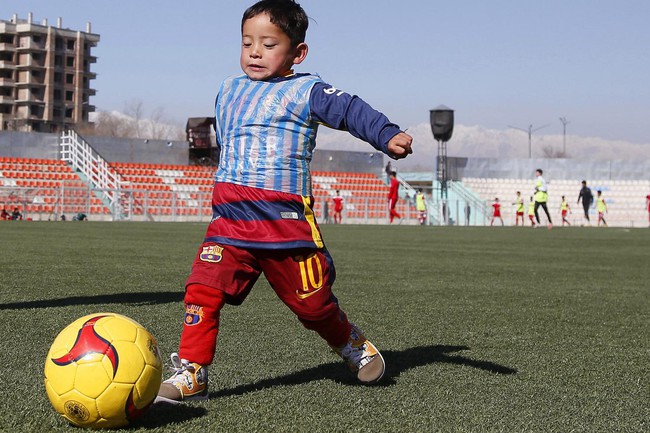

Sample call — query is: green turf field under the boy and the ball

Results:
[0,222,650,432]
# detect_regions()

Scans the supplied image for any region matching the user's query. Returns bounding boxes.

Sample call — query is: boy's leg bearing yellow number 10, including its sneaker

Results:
[260,249,385,384]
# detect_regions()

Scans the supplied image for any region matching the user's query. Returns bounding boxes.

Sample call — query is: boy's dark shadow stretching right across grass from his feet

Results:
[210,345,517,398]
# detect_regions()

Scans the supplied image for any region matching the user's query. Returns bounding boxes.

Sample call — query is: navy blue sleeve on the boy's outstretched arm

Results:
[310,82,401,154]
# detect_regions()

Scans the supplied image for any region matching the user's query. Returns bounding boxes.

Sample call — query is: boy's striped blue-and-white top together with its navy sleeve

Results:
[215,74,400,196]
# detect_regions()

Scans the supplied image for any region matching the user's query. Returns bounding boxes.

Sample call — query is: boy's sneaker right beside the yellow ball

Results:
[154,353,208,404]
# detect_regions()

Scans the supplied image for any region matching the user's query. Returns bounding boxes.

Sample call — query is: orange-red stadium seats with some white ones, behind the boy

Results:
[0,157,417,223]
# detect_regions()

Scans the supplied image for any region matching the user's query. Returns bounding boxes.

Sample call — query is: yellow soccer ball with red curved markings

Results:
[45,313,162,428]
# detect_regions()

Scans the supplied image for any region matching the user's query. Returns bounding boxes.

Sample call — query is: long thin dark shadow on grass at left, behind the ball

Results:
[0,291,185,310]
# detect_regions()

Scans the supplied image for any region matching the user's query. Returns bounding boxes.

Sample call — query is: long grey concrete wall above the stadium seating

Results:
[0,131,650,181]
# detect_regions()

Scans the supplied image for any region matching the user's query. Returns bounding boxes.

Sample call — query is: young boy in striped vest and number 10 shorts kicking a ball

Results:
[157,0,412,403]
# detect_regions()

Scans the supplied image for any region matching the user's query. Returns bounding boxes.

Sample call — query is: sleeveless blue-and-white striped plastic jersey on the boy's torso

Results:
[215,75,321,196]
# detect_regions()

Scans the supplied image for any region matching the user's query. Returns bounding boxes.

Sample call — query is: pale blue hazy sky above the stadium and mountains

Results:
[8,0,650,146]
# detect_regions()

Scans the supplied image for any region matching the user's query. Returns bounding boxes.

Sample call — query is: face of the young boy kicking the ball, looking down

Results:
[239,14,307,80]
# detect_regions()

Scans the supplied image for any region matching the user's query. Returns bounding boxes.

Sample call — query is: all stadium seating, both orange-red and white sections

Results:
[0,152,650,227]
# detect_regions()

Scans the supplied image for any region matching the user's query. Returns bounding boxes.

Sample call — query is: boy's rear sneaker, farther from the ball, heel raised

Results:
[332,324,386,385]
